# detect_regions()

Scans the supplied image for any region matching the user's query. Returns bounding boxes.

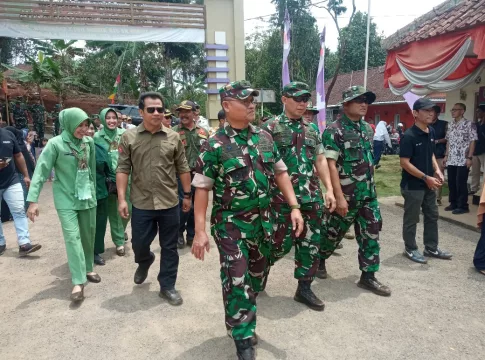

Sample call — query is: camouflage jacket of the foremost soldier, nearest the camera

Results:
[195,122,281,239]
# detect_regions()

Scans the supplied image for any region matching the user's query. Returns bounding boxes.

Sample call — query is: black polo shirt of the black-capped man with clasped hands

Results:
[399,125,436,190]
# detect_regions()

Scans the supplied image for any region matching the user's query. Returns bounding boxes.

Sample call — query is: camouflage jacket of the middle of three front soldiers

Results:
[263,113,324,204]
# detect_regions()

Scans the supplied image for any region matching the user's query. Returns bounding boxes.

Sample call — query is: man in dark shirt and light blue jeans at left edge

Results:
[0,128,41,256]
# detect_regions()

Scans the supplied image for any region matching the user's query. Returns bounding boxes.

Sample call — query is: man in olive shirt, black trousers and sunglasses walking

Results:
[116,92,192,305]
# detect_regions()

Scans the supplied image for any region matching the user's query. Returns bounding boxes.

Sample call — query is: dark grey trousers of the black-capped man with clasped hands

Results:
[401,188,439,251]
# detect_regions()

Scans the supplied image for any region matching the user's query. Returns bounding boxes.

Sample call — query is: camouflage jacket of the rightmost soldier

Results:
[323,115,377,201]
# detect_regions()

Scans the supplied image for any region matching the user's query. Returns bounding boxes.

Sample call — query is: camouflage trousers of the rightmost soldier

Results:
[320,199,382,272]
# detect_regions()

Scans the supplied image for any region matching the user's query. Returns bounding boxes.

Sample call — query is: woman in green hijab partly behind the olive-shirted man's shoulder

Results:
[94,108,129,265]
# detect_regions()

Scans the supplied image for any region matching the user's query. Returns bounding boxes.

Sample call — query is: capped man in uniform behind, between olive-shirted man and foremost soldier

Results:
[172,100,209,249]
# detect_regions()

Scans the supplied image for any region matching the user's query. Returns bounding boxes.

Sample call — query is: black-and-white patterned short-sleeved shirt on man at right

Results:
[446,119,478,166]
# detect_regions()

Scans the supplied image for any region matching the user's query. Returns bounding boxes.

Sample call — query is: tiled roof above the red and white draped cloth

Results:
[383,0,485,51]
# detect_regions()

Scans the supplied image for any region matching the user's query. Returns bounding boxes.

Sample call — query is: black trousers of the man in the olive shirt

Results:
[131,205,180,290]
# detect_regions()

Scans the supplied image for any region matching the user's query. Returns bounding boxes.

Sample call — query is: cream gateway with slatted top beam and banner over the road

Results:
[0,0,245,124]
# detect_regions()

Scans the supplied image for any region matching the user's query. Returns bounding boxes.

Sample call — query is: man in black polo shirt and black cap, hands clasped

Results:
[400,99,452,264]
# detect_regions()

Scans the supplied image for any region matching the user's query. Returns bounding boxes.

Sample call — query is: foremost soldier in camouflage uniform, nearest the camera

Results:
[192,81,303,359]
